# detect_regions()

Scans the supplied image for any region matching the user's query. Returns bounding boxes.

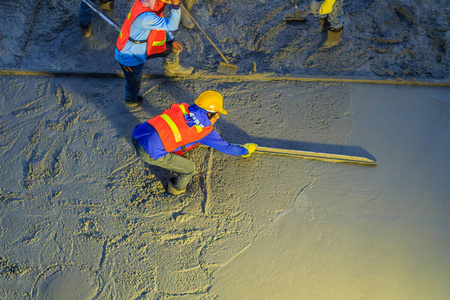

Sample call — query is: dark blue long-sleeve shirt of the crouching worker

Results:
[133,105,248,159]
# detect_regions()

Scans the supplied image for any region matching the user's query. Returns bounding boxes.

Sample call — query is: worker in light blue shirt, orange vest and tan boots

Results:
[115,0,194,106]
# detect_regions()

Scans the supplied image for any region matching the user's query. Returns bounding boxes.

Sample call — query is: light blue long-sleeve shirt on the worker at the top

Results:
[115,5,181,67]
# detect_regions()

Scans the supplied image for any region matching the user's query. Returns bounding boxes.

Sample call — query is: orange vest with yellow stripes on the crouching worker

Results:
[147,103,213,154]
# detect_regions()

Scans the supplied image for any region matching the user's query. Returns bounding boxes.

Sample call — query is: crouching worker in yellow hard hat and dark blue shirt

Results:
[133,91,257,195]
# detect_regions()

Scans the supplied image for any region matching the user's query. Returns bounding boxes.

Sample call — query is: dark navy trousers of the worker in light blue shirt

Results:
[119,44,172,102]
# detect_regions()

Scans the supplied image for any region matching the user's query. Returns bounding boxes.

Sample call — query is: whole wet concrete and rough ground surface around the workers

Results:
[0,0,450,300]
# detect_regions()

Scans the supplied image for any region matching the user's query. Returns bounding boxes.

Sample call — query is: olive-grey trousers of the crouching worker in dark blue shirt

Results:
[133,137,195,190]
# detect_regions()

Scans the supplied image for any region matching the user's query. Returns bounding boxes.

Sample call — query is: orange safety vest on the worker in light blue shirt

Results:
[116,0,166,56]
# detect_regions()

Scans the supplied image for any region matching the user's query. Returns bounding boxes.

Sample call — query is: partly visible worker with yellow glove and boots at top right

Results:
[311,0,344,51]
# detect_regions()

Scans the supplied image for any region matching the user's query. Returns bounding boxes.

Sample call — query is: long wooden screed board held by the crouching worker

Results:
[250,146,377,165]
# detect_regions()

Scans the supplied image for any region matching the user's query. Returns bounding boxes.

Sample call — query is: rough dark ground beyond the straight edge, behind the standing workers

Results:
[0,0,450,79]
